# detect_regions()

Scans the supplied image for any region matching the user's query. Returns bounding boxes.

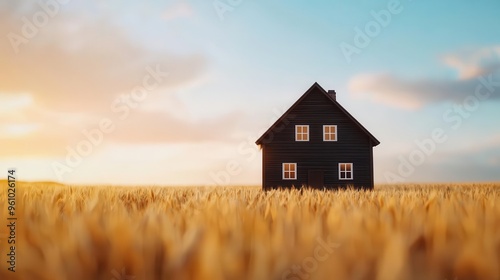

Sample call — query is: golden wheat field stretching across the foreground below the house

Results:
[0,183,500,280]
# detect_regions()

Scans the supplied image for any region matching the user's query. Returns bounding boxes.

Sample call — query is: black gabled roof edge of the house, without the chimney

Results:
[255,82,380,146]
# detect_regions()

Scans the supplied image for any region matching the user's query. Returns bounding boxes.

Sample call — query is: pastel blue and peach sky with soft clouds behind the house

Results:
[0,0,500,186]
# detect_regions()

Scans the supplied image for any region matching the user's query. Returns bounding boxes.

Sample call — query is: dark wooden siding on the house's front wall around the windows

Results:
[262,86,373,189]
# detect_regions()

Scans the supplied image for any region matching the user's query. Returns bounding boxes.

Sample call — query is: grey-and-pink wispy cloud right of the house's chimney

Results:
[349,46,500,110]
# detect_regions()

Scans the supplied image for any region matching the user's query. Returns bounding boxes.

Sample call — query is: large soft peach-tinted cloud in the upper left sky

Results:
[0,12,206,111]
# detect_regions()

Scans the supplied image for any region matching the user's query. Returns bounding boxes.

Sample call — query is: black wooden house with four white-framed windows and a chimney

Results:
[256,83,380,190]
